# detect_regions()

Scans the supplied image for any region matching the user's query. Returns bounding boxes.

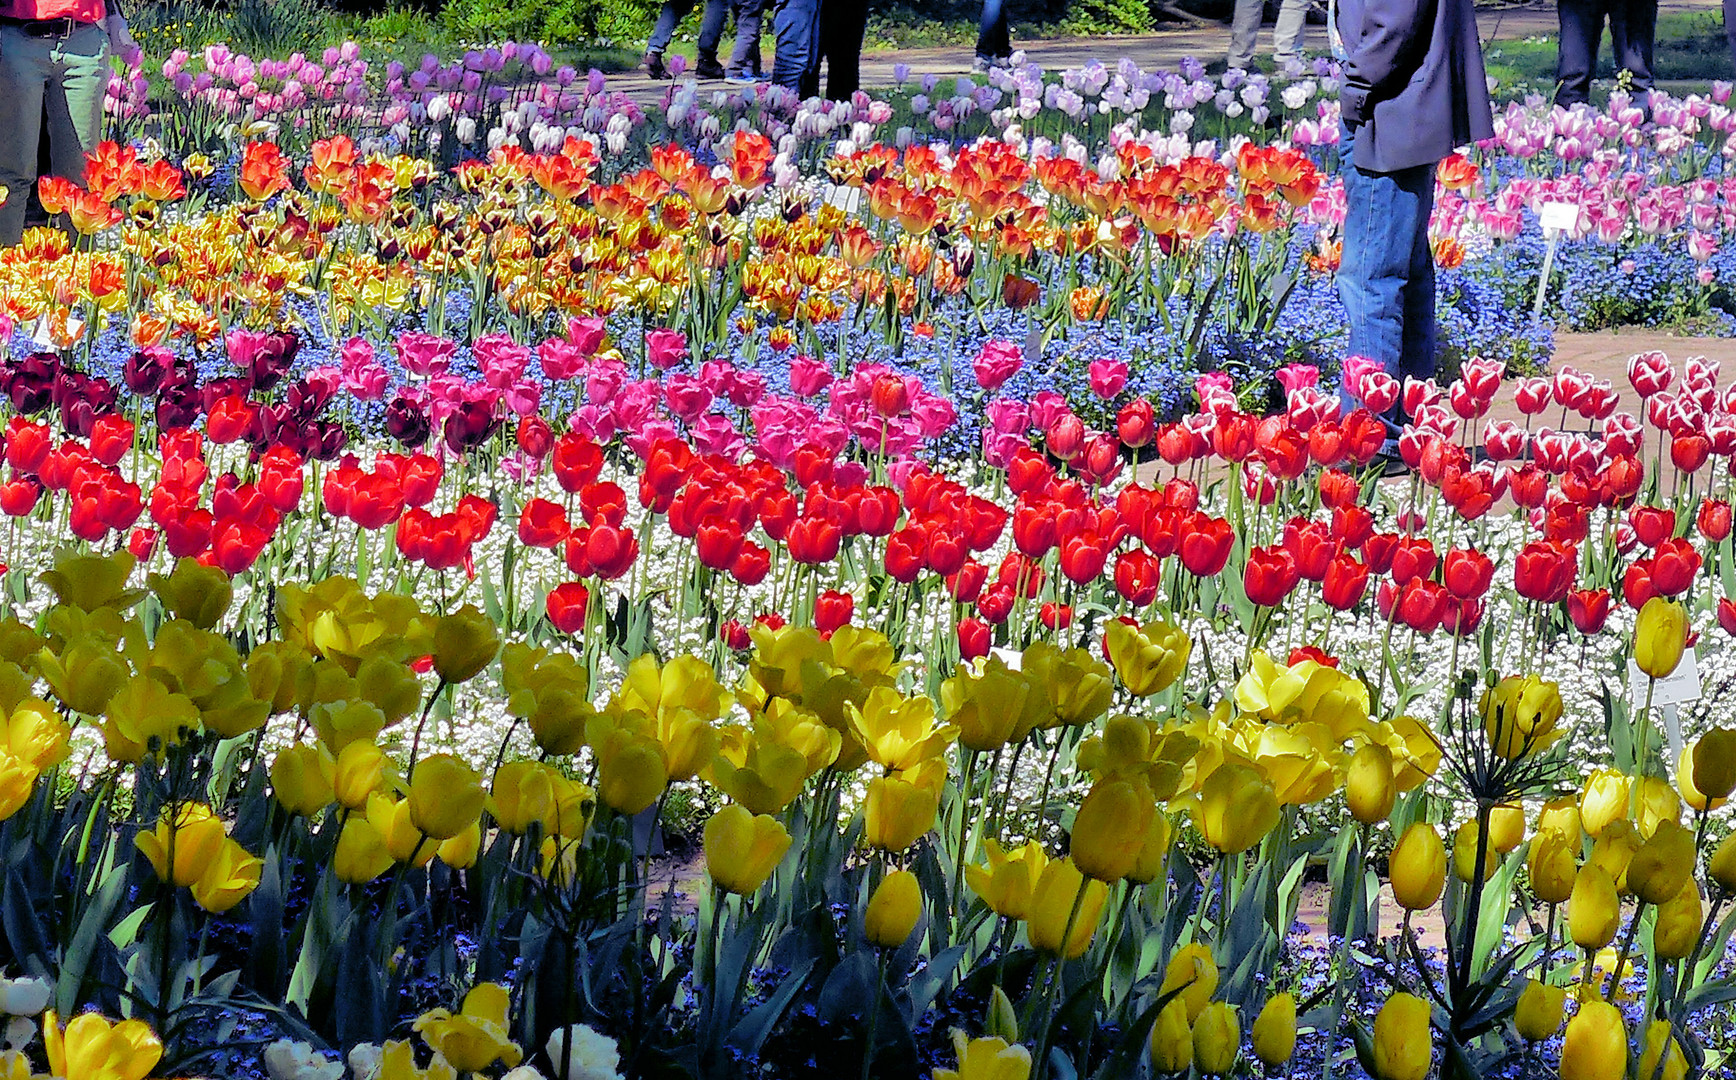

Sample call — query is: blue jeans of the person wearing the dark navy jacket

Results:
[1338,134,1434,423]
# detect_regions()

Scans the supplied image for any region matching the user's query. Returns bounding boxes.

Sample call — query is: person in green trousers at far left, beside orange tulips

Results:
[0,0,137,247]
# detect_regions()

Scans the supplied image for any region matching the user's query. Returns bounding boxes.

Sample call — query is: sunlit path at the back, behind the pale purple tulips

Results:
[609,0,1719,104]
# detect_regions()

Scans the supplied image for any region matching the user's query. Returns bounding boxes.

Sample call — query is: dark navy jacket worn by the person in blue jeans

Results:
[1338,0,1495,172]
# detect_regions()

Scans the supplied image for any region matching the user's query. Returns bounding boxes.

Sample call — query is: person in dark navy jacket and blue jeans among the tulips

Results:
[1333,0,1495,447]
